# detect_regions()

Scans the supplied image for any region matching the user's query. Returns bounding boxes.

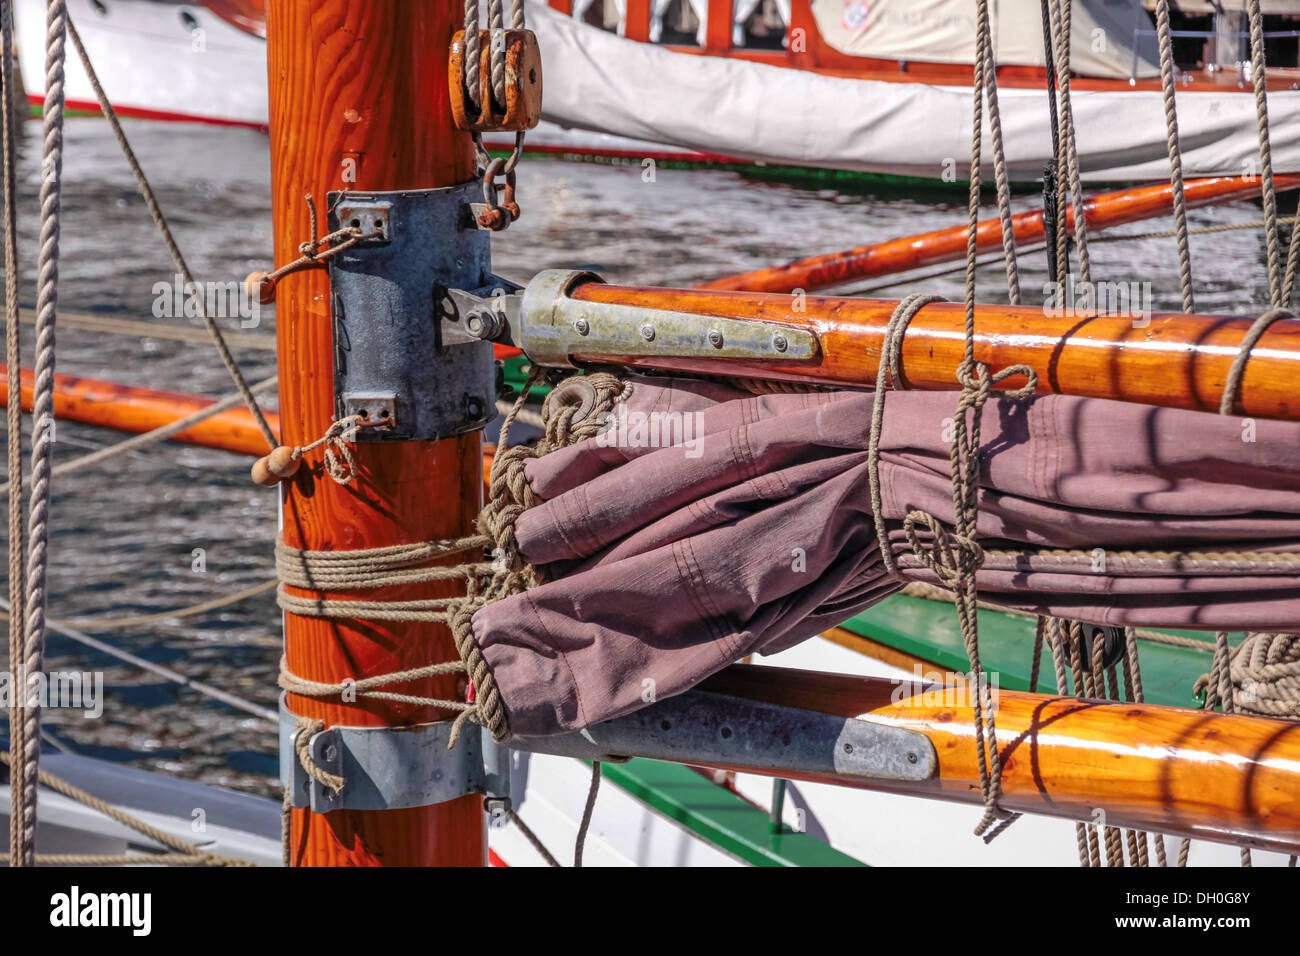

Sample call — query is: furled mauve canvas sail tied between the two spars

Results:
[473,377,1300,735]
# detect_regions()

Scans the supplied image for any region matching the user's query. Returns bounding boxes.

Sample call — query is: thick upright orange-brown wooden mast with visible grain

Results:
[267,0,488,866]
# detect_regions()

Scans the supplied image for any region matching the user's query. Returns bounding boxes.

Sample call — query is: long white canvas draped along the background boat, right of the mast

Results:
[528,3,1300,182]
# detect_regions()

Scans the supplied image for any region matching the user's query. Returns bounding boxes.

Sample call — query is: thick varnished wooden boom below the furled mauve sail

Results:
[701,665,1300,853]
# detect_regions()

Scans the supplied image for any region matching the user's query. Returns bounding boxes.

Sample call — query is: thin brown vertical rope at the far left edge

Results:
[0,0,27,874]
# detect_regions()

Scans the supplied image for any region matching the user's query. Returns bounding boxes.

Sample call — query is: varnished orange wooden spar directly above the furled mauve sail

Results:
[569,282,1300,420]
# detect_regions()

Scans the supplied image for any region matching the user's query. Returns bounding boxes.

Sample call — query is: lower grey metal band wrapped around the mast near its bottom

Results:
[280,695,510,813]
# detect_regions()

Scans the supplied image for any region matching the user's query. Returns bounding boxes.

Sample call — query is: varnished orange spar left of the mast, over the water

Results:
[0,368,280,455]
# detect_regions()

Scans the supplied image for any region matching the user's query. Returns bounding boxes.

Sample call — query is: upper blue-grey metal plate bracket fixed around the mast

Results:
[329,182,497,441]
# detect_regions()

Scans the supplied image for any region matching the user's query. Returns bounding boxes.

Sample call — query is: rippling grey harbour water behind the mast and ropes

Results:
[0,118,1266,796]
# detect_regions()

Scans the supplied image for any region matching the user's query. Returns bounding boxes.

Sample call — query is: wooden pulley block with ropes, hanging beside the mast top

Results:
[447,30,542,133]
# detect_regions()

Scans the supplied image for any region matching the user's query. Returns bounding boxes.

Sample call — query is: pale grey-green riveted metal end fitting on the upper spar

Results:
[498,269,820,368]
